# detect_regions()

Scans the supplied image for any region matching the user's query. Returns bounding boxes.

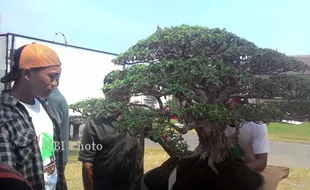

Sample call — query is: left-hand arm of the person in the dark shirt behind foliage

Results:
[78,119,96,190]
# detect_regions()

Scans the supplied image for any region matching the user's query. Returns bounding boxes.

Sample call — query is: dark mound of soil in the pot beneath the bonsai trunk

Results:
[144,158,264,190]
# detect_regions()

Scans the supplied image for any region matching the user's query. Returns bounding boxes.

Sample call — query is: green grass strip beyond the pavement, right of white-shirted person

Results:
[268,122,310,144]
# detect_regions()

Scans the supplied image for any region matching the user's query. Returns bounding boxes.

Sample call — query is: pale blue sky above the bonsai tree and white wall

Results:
[0,0,310,55]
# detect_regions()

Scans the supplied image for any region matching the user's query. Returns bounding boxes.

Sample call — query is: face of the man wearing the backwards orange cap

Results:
[29,66,61,99]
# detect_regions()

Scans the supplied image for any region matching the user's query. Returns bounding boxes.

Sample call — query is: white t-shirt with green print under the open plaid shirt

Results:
[21,99,57,190]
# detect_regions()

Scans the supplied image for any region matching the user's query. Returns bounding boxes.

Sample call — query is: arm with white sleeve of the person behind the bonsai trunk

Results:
[247,124,269,172]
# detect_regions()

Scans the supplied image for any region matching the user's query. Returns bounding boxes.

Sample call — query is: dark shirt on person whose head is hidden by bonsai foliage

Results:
[78,118,144,190]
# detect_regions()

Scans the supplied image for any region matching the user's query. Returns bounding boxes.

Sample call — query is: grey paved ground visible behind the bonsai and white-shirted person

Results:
[145,133,310,169]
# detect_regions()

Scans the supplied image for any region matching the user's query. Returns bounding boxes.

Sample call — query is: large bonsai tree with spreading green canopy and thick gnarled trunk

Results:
[71,25,310,189]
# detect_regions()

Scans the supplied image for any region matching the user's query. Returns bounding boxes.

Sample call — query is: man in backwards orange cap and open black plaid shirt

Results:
[0,43,67,190]
